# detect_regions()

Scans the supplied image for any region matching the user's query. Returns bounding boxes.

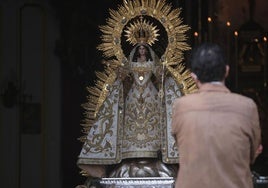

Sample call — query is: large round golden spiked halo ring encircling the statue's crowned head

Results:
[97,0,190,65]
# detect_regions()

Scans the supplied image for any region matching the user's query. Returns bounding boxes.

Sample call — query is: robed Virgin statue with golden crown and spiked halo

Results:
[77,0,196,185]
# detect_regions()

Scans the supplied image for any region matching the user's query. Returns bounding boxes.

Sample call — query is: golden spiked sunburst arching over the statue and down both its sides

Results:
[81,0,196,123]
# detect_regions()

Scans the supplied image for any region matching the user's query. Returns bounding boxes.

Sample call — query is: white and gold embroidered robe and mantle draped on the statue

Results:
[77,44,181,167]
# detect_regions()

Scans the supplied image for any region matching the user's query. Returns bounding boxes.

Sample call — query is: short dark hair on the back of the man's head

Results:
[191,43,226,83]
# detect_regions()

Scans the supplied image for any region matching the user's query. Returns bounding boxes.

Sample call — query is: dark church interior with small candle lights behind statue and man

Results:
[0,0,268,188]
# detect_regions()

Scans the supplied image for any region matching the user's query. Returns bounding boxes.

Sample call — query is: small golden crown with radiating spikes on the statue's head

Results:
[124,16,159,46]
